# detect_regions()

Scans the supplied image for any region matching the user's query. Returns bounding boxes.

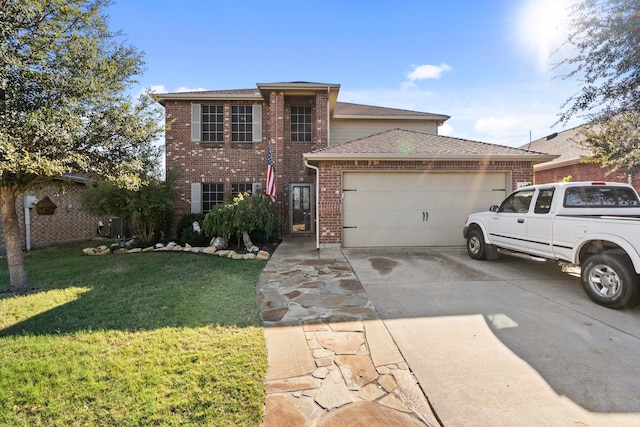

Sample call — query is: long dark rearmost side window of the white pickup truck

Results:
[564,186,640,208]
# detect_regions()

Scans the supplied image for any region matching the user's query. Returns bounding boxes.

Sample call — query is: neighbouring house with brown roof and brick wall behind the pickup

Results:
[520,125,640,190]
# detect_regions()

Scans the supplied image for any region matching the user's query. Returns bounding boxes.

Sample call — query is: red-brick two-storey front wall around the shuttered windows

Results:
[165,91,328,234]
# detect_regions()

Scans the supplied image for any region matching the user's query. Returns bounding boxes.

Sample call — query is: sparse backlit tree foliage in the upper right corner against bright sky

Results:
[558,0,640,123]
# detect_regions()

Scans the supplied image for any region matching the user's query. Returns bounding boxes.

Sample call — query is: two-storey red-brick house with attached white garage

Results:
[158,82,555,247]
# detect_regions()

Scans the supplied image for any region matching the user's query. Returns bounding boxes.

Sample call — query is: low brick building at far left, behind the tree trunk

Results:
[0,175,107,251]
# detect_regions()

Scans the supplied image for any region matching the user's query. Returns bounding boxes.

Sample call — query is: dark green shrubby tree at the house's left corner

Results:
[80,178,175,246]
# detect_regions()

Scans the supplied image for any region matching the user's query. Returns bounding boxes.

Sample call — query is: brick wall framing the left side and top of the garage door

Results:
[316,161,533,245]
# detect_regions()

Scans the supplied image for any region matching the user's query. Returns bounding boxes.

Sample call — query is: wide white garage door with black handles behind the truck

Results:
[342,172,507,247]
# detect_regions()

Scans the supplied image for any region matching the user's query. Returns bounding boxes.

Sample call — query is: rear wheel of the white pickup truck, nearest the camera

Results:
[581,252,640,308]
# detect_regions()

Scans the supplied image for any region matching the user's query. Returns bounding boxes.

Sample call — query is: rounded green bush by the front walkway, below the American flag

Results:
[202,193,278,244]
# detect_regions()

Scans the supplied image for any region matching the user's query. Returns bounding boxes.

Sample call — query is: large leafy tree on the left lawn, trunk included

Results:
[0,0,162,290]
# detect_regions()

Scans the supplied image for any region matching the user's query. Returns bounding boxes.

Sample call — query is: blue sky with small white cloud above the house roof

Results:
[106,0,582,147]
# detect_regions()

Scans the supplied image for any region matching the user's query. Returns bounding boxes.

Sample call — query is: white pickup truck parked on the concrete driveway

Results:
[463,182,640,308]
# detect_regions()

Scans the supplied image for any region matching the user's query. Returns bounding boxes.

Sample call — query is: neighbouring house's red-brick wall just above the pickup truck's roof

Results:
[534,162,640,191]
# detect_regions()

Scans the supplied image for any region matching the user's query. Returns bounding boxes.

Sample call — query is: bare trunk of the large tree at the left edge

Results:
[0,187,29,291]
